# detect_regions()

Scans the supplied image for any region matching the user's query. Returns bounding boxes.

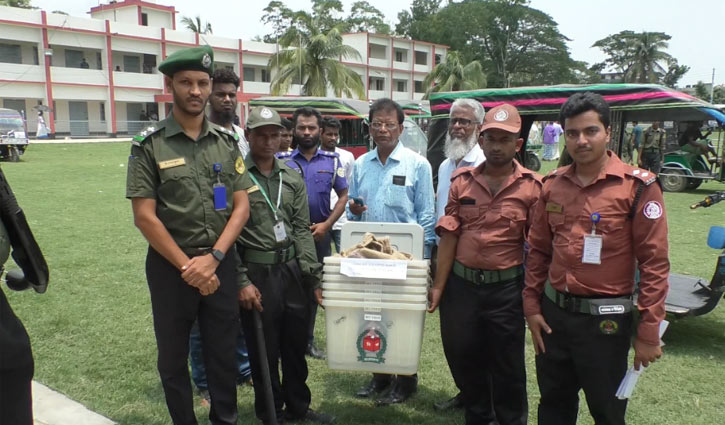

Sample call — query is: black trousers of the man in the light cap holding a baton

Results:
[241,255,312,422]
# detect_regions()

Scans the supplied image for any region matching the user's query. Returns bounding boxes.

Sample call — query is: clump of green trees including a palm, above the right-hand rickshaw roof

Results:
[592,30,676,85]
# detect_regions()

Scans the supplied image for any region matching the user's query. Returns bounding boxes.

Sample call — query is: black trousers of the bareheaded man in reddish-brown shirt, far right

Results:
[536,297,633,425]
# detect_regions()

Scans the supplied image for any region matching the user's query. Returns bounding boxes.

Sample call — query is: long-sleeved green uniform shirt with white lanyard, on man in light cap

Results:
[238,155,322,288]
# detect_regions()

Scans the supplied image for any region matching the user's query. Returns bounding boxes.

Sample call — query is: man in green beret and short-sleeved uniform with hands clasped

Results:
[126,46,251,425]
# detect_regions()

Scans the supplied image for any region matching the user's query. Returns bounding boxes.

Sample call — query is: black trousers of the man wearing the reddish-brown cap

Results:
[440,273,528,425]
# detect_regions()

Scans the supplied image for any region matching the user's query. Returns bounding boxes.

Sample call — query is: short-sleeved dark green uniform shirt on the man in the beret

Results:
[126,115,252,249]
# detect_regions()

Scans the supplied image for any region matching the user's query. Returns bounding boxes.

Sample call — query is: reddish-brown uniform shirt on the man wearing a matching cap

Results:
[436,161,541,270]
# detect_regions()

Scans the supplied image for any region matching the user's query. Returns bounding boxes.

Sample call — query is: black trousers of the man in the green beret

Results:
[146,247,240,425]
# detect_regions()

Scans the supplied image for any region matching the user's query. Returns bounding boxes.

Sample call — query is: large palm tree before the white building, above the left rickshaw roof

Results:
[268,19,365,99]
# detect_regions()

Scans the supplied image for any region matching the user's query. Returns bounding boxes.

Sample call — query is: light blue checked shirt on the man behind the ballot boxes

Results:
[347,142,435,258]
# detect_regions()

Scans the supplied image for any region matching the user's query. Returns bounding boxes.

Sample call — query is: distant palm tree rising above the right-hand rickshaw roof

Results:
[625,31,673,83]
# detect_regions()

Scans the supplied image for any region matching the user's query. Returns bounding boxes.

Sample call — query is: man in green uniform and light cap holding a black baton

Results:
[239,107,335,423]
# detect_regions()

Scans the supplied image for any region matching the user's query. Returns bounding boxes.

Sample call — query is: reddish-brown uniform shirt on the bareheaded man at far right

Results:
[523,151,670,345]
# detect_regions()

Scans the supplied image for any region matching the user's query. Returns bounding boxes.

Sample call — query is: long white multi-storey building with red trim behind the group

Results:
[0,0,447,136]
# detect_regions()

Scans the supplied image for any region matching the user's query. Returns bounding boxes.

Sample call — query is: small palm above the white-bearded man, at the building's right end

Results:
[423,52,486,99]
